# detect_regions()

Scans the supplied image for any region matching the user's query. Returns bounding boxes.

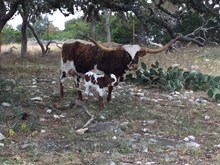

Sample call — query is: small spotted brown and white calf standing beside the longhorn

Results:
[84,71,118,110]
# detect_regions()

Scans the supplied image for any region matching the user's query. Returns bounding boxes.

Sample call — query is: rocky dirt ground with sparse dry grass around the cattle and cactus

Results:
[0,44,220,165]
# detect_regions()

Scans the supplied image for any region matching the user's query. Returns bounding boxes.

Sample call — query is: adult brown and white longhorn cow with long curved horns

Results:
[60,37,177,101]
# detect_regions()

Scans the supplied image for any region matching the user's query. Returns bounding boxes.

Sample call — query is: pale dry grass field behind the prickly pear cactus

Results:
[142,47,220,75]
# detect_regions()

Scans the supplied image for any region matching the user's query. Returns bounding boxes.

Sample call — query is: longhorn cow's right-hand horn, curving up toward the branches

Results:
[139,37,179,57]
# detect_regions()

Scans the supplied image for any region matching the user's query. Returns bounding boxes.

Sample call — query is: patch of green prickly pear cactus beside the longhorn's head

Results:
[127,61,220,101]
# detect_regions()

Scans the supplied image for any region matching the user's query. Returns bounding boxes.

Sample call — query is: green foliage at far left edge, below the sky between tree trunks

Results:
[2,25,21,44]
